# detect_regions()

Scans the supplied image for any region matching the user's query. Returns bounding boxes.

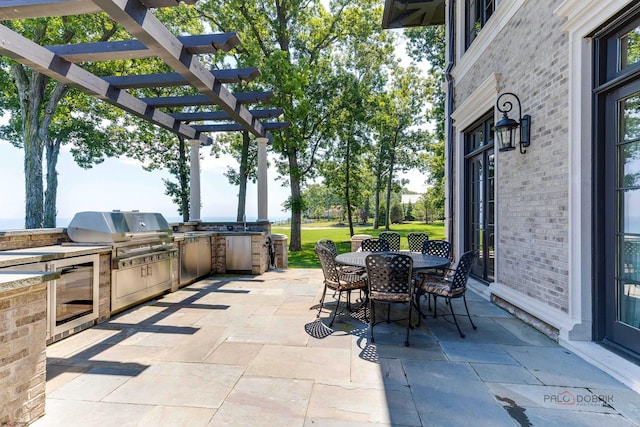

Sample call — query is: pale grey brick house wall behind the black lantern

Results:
[455,0,569,312]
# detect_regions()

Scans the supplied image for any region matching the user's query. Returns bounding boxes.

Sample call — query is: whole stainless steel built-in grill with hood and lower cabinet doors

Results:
[67,211,177,312]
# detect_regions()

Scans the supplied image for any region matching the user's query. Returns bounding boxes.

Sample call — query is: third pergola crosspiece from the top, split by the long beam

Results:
[103,68,261,89]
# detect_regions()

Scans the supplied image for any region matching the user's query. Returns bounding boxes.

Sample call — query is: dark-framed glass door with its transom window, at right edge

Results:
[593,11,640,357]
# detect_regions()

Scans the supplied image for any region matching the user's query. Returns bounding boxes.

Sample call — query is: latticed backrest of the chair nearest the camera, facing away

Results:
[365,253,413,301]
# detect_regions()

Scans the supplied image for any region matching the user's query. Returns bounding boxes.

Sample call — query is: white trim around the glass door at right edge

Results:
[554,0,640,391]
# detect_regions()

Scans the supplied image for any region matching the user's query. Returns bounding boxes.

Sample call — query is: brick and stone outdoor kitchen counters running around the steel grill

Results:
[0,219,287,425]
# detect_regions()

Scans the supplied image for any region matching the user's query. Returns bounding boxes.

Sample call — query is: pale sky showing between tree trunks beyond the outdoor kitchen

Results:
[0,141,426,229]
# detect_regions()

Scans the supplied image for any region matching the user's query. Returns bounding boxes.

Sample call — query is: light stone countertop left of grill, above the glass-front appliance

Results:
[0,245,111,268]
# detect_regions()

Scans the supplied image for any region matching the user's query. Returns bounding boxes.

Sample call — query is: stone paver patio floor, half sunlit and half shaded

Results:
[32,269,640,427]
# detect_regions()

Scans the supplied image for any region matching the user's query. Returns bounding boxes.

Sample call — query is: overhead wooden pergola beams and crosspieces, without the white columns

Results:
[0,0,273,143]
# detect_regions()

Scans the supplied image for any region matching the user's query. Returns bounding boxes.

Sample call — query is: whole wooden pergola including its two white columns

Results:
[0,0,289,221]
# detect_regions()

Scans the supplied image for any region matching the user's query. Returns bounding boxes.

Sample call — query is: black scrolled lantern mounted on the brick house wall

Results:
[495,92,531,154]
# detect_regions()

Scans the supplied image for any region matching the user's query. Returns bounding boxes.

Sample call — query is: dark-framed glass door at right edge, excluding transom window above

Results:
[605,81,640,353]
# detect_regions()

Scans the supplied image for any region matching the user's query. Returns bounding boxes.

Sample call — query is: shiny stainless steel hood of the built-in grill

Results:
[67,211,173,243]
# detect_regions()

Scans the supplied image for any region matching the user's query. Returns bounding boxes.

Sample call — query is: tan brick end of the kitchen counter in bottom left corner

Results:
[0,283,47,425]
